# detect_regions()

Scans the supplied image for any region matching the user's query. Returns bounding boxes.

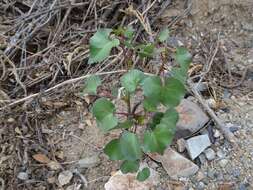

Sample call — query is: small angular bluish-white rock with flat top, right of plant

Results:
[186,134,211,160]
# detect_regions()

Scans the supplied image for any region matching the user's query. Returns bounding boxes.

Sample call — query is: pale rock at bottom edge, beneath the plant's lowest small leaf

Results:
[105,164,159,190]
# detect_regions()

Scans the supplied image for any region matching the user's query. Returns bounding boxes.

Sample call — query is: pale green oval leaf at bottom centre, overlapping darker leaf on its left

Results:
[120,132,142,161]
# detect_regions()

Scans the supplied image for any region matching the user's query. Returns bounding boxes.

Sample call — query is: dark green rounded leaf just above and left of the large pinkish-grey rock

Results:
[160,78,185,107]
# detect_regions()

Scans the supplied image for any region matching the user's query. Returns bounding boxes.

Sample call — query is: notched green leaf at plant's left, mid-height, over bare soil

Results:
[92,98,118,131]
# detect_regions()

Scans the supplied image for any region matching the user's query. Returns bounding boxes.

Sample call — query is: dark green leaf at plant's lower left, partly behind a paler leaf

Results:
[104,139,124,160]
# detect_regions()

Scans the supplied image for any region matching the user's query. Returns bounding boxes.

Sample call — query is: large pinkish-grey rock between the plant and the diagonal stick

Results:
[177,99,209,133]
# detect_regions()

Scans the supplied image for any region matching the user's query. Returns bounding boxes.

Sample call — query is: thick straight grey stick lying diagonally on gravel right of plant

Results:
[187,79,237,147]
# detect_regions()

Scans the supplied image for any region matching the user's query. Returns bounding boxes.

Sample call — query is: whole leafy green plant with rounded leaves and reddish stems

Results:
[85,27,191,181]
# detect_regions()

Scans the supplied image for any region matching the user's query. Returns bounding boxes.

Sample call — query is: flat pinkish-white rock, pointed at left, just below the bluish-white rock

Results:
[148,148,199,179]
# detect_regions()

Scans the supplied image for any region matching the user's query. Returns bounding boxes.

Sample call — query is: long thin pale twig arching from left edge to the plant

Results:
[0,70,126,111]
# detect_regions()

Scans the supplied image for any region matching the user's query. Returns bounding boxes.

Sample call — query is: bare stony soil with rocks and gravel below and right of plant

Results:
[0,0,253,190]
